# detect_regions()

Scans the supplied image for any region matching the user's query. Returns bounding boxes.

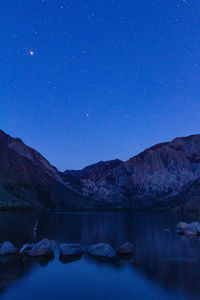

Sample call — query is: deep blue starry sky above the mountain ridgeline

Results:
[0,0,200,170]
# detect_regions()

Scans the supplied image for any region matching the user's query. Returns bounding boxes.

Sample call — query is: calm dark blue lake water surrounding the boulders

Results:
[0,212,200,300]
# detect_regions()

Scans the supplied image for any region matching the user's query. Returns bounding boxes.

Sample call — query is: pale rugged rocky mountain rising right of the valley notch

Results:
[64,135,200,209]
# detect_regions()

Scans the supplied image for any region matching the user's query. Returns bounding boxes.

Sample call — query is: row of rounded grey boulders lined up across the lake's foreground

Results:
[0,238,134,261]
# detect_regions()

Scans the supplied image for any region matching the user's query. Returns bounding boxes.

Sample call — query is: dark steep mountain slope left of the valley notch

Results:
[0,130,90,209]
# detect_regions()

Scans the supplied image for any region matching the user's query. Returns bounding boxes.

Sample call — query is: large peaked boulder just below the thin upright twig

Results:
[29,239,54,256]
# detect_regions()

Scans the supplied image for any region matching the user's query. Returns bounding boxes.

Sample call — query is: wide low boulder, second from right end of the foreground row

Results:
[88,243,116,259]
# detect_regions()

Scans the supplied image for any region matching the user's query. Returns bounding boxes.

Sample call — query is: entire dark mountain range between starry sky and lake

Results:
[0,130,200,210]
